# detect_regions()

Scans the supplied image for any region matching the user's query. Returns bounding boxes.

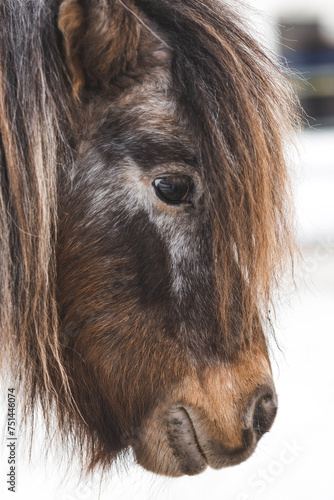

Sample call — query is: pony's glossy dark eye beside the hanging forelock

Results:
[152,175,193,205]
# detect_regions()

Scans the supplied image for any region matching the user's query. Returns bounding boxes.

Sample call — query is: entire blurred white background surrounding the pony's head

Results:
[0,0,334,500]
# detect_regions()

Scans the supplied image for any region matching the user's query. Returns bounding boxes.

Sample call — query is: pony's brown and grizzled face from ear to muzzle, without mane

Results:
[57,1,277,476]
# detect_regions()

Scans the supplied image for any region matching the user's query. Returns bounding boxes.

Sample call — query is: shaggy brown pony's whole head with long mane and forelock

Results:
[0,0,295,476]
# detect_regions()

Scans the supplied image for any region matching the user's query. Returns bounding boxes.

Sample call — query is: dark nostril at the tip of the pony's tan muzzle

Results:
[244,385,277,439]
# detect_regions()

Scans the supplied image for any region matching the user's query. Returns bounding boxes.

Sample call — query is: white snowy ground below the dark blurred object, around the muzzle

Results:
[0,130,334,500]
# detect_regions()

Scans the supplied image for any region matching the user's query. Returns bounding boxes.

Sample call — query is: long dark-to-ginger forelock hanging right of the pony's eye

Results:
[136,0,298,340]
